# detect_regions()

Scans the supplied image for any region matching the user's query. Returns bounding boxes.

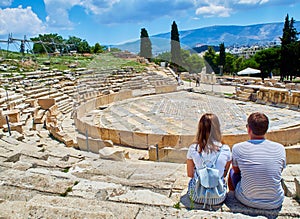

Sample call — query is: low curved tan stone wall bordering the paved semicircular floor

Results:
[75,86,300,163]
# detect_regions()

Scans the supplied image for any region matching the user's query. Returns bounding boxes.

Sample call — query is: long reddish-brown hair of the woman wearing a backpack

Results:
[196,113,222,153]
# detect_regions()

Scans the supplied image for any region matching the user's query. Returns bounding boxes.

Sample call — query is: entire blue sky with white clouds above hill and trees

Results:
[0,0,300,46]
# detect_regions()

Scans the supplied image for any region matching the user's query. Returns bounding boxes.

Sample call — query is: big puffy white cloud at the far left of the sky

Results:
[0,6,45,35]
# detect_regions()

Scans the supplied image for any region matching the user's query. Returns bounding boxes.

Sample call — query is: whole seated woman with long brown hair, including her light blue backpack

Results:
[187,113,231,207]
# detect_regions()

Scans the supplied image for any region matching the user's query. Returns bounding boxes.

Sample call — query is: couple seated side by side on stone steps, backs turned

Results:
[187,112,286,209]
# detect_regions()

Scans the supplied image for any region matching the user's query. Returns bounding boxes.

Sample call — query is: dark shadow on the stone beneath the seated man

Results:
[224,192,281,219]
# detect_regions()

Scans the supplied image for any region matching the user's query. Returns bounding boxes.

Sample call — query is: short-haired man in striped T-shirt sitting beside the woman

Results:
[228,112,286,209]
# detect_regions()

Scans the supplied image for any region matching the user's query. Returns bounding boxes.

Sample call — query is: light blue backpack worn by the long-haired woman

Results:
[188,148,227,208]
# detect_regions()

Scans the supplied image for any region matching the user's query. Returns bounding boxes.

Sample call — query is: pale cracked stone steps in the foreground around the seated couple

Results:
[0,133,300,219]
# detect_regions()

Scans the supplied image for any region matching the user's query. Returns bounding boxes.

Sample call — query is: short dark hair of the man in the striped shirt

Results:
[247,112,269,135]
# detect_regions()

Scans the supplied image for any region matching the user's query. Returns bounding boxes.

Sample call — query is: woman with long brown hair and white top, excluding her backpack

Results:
[187,113,231,205]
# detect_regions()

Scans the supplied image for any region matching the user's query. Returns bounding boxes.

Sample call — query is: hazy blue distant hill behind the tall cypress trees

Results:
[113,22,300,55]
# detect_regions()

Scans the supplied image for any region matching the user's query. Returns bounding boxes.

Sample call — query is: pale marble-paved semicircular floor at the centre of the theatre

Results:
[95,91,300,135]
